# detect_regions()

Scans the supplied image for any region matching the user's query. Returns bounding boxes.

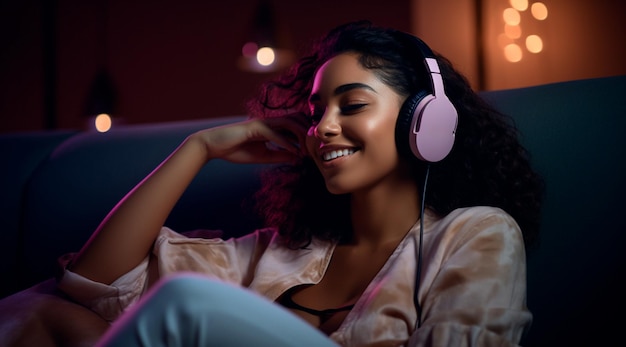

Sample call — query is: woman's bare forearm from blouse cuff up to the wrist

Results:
[71,137,208,284]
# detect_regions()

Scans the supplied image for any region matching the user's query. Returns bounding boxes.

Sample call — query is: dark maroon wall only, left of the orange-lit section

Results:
[0,0,410,132]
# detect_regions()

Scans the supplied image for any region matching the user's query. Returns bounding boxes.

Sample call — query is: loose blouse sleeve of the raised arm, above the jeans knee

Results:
[57,227,270,321]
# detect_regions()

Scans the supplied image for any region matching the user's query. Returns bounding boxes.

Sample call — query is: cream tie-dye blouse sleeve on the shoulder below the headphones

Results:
[408,208,532,347]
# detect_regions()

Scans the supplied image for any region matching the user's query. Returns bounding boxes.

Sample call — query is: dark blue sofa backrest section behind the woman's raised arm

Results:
[18,117,270,292]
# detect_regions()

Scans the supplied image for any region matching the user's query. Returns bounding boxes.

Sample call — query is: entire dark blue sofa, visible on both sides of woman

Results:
[0,76,626,346]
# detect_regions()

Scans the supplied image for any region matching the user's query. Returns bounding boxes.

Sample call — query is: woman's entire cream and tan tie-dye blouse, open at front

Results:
[58,206,532,346]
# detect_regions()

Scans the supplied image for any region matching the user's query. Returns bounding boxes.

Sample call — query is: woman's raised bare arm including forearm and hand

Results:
[71,117,306,284]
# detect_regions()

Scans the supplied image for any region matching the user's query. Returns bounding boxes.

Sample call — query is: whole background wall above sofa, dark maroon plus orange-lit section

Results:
[0,0,626,133]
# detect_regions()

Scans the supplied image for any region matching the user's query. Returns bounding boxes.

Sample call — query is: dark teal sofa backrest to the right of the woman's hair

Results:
[484,76,626,346]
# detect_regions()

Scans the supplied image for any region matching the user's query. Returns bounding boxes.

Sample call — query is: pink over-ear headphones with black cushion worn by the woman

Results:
[396,34,458,163]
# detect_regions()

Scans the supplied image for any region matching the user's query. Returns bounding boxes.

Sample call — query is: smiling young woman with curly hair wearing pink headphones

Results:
[11,22,542,346]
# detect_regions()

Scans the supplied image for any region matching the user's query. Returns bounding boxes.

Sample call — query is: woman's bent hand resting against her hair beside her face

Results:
[189,113,308,163]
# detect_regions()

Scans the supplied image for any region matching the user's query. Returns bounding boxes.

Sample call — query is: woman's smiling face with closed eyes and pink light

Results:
[306,53,408,194]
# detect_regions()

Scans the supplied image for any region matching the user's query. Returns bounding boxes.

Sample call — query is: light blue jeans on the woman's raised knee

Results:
[98,274,337,347]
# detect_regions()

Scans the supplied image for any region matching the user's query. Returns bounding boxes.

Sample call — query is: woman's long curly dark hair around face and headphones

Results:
[248,21,543,248]
